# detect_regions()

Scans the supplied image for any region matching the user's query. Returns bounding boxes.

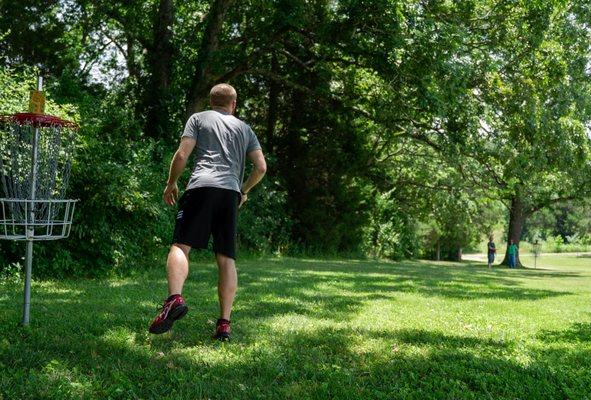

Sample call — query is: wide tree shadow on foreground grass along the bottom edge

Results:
[0,327,591,399]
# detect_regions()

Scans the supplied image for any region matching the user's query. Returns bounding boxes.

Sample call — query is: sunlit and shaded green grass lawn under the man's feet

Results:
[0,255,591,399]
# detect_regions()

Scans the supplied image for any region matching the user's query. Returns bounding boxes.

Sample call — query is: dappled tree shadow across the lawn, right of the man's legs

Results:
[241,261,577,308]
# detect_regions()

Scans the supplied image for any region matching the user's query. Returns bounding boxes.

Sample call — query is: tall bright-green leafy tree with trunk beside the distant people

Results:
[360,1,591,268]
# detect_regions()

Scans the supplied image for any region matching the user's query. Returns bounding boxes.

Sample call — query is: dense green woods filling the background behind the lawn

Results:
[0,0,591,276]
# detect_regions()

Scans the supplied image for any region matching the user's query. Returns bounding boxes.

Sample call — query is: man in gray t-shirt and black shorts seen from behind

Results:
[149,84,267,340]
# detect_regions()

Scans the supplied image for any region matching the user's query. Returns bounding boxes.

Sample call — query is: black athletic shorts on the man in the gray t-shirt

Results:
[172,187,240,259]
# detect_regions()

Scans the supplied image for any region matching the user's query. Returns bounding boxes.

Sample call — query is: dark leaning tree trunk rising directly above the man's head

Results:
[186,0,234,117]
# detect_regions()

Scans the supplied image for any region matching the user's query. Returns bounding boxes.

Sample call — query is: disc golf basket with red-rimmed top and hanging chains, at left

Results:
[0,78,78,325]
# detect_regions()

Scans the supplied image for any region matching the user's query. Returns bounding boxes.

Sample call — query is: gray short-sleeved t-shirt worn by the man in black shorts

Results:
[182,110,261,192]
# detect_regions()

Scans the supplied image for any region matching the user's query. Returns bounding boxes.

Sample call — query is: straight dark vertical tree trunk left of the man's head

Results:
[144,0,174,138]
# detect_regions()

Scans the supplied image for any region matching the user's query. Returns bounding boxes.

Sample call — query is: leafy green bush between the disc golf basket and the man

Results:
[41,136,174,276]
